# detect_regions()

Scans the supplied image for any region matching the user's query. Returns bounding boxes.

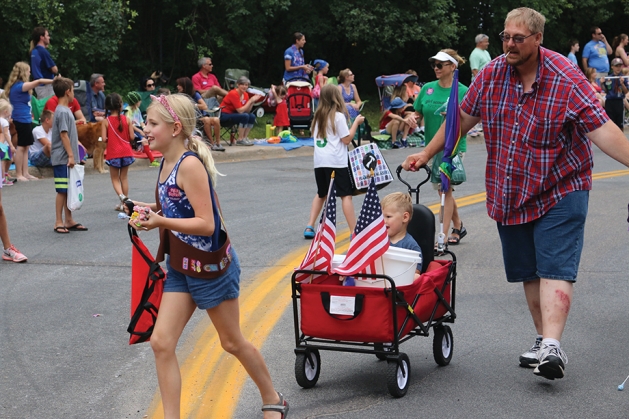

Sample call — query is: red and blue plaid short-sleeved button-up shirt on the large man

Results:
[461,47,609,225]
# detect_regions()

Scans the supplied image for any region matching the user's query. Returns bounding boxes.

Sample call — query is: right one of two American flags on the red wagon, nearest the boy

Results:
[334,178,389,276]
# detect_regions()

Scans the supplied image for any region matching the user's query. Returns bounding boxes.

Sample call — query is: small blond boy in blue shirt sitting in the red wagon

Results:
[380,192,422,278]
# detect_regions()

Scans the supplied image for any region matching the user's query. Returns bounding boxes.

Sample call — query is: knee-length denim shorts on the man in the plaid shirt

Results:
[498,191,590,282]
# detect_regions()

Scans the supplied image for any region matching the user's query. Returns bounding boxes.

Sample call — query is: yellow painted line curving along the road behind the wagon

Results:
[148,170,629,419]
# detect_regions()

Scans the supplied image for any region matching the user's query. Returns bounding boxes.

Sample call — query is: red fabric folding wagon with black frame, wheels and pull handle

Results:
[291,166,456,398]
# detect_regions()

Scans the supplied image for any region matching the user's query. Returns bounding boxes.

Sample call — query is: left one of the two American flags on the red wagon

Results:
[295,178,336,282]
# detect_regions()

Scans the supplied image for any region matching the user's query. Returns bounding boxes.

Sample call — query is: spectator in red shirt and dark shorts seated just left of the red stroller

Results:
[221,77,260,146]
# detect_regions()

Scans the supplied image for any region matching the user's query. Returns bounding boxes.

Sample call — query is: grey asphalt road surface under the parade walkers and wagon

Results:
[0,144,629,419]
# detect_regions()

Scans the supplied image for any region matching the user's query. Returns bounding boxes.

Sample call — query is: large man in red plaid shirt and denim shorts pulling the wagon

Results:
[403,8,629,380]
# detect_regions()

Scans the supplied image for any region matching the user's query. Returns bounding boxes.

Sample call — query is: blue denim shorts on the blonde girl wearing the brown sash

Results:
[164,247,240,310]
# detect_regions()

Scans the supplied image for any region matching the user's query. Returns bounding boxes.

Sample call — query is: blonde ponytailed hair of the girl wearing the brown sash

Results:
[147,93,224,186]
